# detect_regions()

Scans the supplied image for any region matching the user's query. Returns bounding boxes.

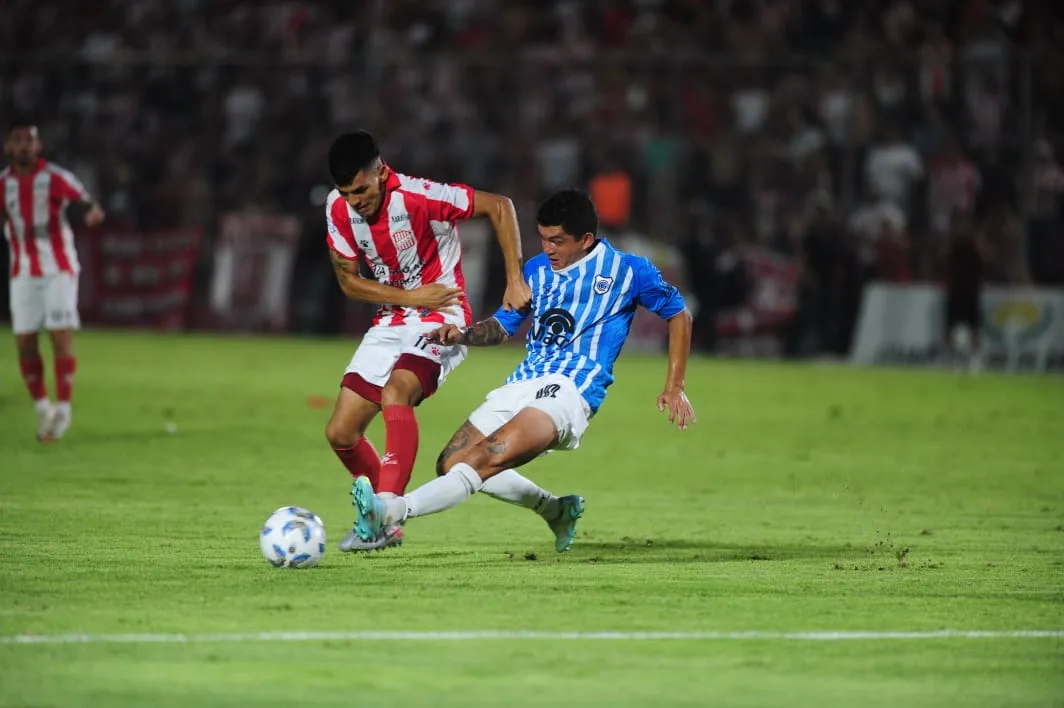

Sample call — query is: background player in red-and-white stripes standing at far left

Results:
[0,120,104,443]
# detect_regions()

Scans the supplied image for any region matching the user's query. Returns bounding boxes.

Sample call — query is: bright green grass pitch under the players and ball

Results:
[0,332,1064,708]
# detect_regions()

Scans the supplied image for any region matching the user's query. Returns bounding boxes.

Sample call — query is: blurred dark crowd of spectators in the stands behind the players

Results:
[0,0,1064,353]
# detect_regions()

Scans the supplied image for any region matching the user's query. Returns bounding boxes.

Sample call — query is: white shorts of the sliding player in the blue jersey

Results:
[469,374,592,450]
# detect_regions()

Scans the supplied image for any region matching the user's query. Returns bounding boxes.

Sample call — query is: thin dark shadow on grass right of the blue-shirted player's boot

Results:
[572,539,853,563]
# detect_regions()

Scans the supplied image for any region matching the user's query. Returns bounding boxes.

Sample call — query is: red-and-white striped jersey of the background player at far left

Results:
[0,160,90,278]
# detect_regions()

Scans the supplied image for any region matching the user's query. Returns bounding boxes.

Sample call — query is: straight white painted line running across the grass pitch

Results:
[0,629,1064,644]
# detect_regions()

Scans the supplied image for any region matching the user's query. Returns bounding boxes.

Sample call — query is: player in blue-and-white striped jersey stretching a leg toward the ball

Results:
[352,190,695,551]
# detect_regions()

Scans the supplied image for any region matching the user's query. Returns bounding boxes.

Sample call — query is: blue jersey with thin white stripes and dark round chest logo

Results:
[495,238,684,412]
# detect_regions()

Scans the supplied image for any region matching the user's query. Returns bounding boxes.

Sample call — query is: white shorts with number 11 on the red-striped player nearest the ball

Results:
[344,323,467,388]
